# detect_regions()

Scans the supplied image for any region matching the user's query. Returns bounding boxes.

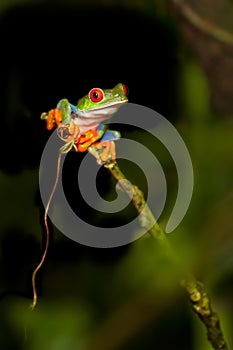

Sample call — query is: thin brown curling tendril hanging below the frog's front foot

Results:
[31,152,62,310]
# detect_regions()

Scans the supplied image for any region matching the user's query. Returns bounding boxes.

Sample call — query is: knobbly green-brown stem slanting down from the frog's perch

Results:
[106,162,227,350]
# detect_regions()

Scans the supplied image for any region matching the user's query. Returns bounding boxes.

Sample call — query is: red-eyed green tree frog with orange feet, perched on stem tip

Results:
[41,83,128,164]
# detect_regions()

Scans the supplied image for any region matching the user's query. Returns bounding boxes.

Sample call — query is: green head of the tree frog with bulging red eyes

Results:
[77,83,128,115]
